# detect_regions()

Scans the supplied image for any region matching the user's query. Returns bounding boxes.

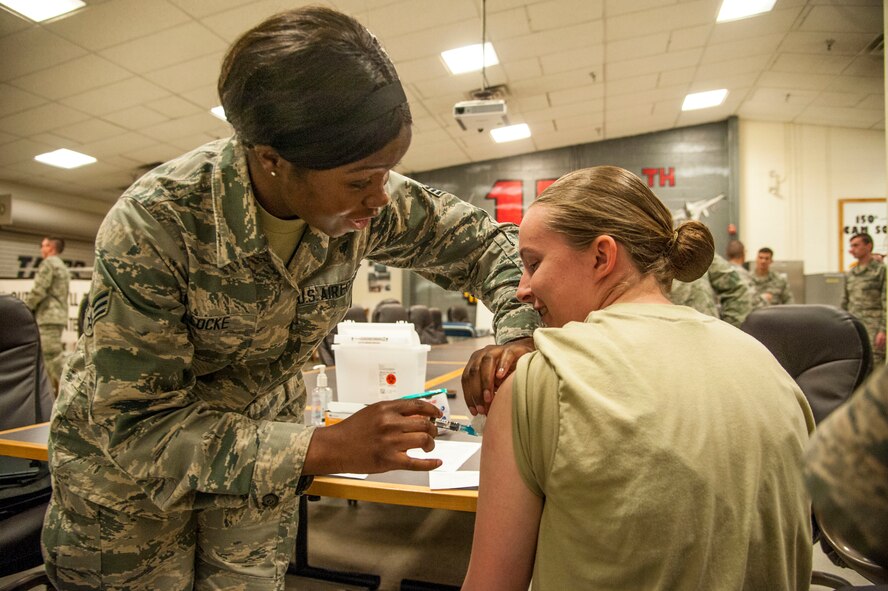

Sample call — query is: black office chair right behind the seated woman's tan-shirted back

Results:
[740,305,873,589]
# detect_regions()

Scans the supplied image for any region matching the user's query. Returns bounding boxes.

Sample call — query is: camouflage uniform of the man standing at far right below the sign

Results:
[842,260,885,365]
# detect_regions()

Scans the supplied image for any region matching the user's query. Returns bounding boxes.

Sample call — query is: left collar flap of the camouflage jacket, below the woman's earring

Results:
[212,136,266,267]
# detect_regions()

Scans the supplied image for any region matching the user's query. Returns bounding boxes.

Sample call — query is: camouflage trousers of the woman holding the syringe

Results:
[42,483,299,591]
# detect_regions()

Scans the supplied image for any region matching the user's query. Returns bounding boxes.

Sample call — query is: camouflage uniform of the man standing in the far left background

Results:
[25,255,70,384]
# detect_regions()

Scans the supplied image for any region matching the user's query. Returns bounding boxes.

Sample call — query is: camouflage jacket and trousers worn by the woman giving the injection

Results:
[43,138,539,589]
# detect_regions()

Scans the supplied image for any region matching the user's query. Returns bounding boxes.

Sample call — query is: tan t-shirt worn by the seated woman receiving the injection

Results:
[513,304,814,591]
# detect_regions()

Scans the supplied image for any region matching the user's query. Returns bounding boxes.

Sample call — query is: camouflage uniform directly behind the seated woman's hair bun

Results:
[669,254,753,326]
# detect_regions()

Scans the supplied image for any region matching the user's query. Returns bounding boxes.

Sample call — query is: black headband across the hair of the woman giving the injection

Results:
[272,80,407,158]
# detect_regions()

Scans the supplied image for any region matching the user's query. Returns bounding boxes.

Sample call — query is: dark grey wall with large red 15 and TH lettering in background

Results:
[405,118,739,320]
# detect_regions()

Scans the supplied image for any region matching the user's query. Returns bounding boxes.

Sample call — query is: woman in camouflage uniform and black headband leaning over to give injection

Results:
[43,8,538,590]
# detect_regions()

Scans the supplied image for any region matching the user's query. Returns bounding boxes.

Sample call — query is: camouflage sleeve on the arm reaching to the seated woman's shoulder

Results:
[367,173,539,343]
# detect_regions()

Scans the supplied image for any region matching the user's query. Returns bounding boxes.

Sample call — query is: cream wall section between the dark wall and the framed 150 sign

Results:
[740,119,886,274]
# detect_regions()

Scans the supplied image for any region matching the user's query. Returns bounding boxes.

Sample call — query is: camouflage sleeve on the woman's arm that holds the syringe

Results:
[88,197,313,510]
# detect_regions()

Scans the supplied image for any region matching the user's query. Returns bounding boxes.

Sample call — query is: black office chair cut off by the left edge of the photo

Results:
[0,295,53,590]
